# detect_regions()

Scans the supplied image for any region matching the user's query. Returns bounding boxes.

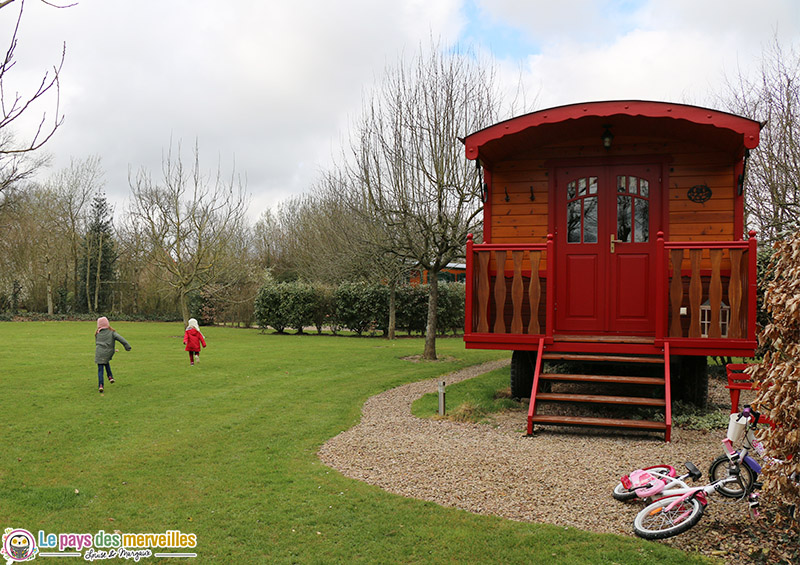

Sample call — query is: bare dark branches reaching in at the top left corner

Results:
[0,0,74,193]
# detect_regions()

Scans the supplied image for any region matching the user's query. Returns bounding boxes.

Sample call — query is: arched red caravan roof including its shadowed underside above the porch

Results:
[463,100,761,164]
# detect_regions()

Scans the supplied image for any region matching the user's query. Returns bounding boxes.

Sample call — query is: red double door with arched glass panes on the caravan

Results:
[554,165,662,335]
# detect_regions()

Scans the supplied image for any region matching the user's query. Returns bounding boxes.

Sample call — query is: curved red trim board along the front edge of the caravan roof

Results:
[464,100,761,159]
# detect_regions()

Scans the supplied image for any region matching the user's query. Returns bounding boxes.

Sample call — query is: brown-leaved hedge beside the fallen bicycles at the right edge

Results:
[748,233,800,516]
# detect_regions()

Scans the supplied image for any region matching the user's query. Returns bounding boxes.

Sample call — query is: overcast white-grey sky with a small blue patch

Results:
[6,0,800,219]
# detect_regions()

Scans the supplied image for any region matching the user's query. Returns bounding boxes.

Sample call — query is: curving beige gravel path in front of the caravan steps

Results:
[319,360,792,563]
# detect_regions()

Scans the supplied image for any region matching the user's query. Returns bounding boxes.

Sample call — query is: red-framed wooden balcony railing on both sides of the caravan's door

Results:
[465,232,756,352]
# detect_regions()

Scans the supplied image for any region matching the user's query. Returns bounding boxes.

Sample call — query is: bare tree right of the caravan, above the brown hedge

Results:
[722,38,800,241]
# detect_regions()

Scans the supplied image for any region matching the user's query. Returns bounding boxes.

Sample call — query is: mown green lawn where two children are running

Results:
[0,320,702,565]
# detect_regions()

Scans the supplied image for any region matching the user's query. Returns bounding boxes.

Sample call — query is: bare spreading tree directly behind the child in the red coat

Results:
[129,139,247,323]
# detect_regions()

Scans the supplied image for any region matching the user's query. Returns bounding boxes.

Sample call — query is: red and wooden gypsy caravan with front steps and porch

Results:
[463,100,761,441]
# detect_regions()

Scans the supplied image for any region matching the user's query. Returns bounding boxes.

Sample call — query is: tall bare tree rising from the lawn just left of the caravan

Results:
[350,40,500,359]
